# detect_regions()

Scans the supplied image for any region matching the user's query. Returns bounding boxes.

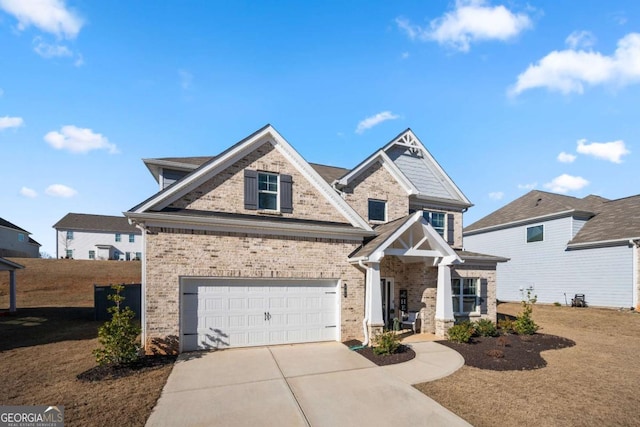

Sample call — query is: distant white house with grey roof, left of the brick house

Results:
[53,213,142,261]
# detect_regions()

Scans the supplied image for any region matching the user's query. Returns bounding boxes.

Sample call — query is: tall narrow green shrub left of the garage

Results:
[93,285,140,365]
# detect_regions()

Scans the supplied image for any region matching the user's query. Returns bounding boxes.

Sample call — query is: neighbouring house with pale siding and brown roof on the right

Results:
[464,190,640,309]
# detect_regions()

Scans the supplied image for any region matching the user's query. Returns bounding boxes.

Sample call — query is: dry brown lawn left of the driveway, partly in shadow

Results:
[0,259,172,426]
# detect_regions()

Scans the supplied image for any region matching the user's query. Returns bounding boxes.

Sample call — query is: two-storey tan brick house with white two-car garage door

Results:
[125,125,506,351]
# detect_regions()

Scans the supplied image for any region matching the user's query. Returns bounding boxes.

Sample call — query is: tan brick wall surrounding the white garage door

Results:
[146,228,364,350]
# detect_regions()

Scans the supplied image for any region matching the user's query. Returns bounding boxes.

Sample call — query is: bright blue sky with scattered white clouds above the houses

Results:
[0,0,640,254]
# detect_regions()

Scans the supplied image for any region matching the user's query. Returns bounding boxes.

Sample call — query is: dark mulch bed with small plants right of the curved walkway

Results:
[438,334,576,371]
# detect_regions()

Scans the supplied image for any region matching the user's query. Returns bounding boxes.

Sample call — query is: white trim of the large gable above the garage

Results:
[129,125,371,230]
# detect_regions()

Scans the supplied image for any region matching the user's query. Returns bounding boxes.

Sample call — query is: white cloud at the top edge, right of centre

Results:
[396,0,532,52]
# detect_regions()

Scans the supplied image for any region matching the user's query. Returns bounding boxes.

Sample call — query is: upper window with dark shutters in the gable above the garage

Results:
[244,169,293,213]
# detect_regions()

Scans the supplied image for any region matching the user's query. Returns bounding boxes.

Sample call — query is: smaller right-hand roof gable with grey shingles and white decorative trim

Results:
[337,129,472,207]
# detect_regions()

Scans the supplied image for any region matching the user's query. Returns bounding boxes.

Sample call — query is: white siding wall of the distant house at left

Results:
[56,230,142,259]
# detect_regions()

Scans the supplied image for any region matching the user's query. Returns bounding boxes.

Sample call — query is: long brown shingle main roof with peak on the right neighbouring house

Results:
[464,190,607,233]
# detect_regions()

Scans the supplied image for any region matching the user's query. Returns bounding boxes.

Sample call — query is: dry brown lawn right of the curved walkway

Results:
[416,304,640,426]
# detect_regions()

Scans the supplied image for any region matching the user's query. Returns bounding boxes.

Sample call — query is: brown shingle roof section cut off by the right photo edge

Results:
[569,195,640,244]
